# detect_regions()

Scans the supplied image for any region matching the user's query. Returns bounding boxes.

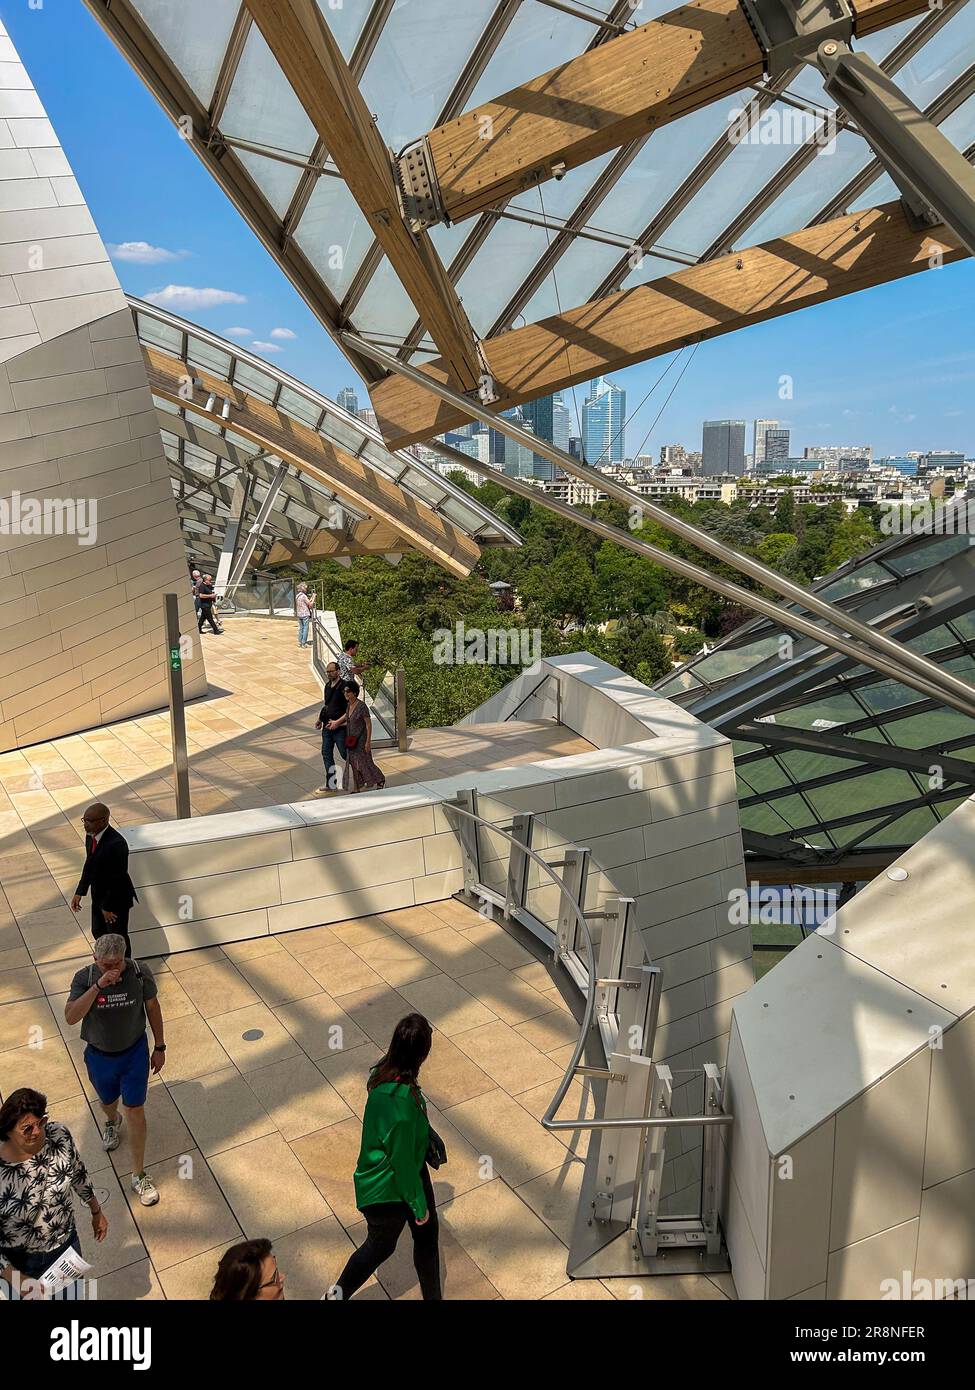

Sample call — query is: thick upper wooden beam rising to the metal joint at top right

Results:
[422,0,934,222]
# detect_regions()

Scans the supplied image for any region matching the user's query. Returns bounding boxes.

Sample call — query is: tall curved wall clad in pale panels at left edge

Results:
[0,25,206,751]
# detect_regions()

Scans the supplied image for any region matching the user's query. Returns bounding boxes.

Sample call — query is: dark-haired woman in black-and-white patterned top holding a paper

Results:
[0,1087,108,1279]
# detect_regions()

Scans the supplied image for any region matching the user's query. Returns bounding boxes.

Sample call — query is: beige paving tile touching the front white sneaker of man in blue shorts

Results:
[123,1150,242,1287]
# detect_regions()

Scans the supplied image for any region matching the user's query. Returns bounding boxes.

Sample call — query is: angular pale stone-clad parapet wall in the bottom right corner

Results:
[723,799,975,1300]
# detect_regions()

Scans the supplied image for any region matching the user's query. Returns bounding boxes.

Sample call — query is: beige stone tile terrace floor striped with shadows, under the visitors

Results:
[0,620,734,1300]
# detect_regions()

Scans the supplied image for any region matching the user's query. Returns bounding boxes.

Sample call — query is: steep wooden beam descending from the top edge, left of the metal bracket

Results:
[246,0,481,391]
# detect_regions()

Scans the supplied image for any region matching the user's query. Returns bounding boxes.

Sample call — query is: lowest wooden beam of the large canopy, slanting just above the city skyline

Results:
[371,202,968,449]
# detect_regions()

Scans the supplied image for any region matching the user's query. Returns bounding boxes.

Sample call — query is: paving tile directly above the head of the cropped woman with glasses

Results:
[210,1134,331,1240]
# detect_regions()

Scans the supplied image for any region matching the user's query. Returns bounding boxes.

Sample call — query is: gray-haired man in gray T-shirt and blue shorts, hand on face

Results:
[64,933,166,1207]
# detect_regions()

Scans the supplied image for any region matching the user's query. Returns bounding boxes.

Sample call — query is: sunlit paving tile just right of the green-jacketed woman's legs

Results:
[440,1177,569,1300]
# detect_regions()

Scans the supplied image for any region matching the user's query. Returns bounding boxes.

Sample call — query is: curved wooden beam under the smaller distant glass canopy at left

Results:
[142,343,480,575]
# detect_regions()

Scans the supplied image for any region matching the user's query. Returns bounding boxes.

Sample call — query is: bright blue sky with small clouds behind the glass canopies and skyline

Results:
[7,0,975,456]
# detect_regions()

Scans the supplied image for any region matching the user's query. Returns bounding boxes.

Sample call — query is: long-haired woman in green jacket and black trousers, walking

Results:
[334,1013,442,1300]
